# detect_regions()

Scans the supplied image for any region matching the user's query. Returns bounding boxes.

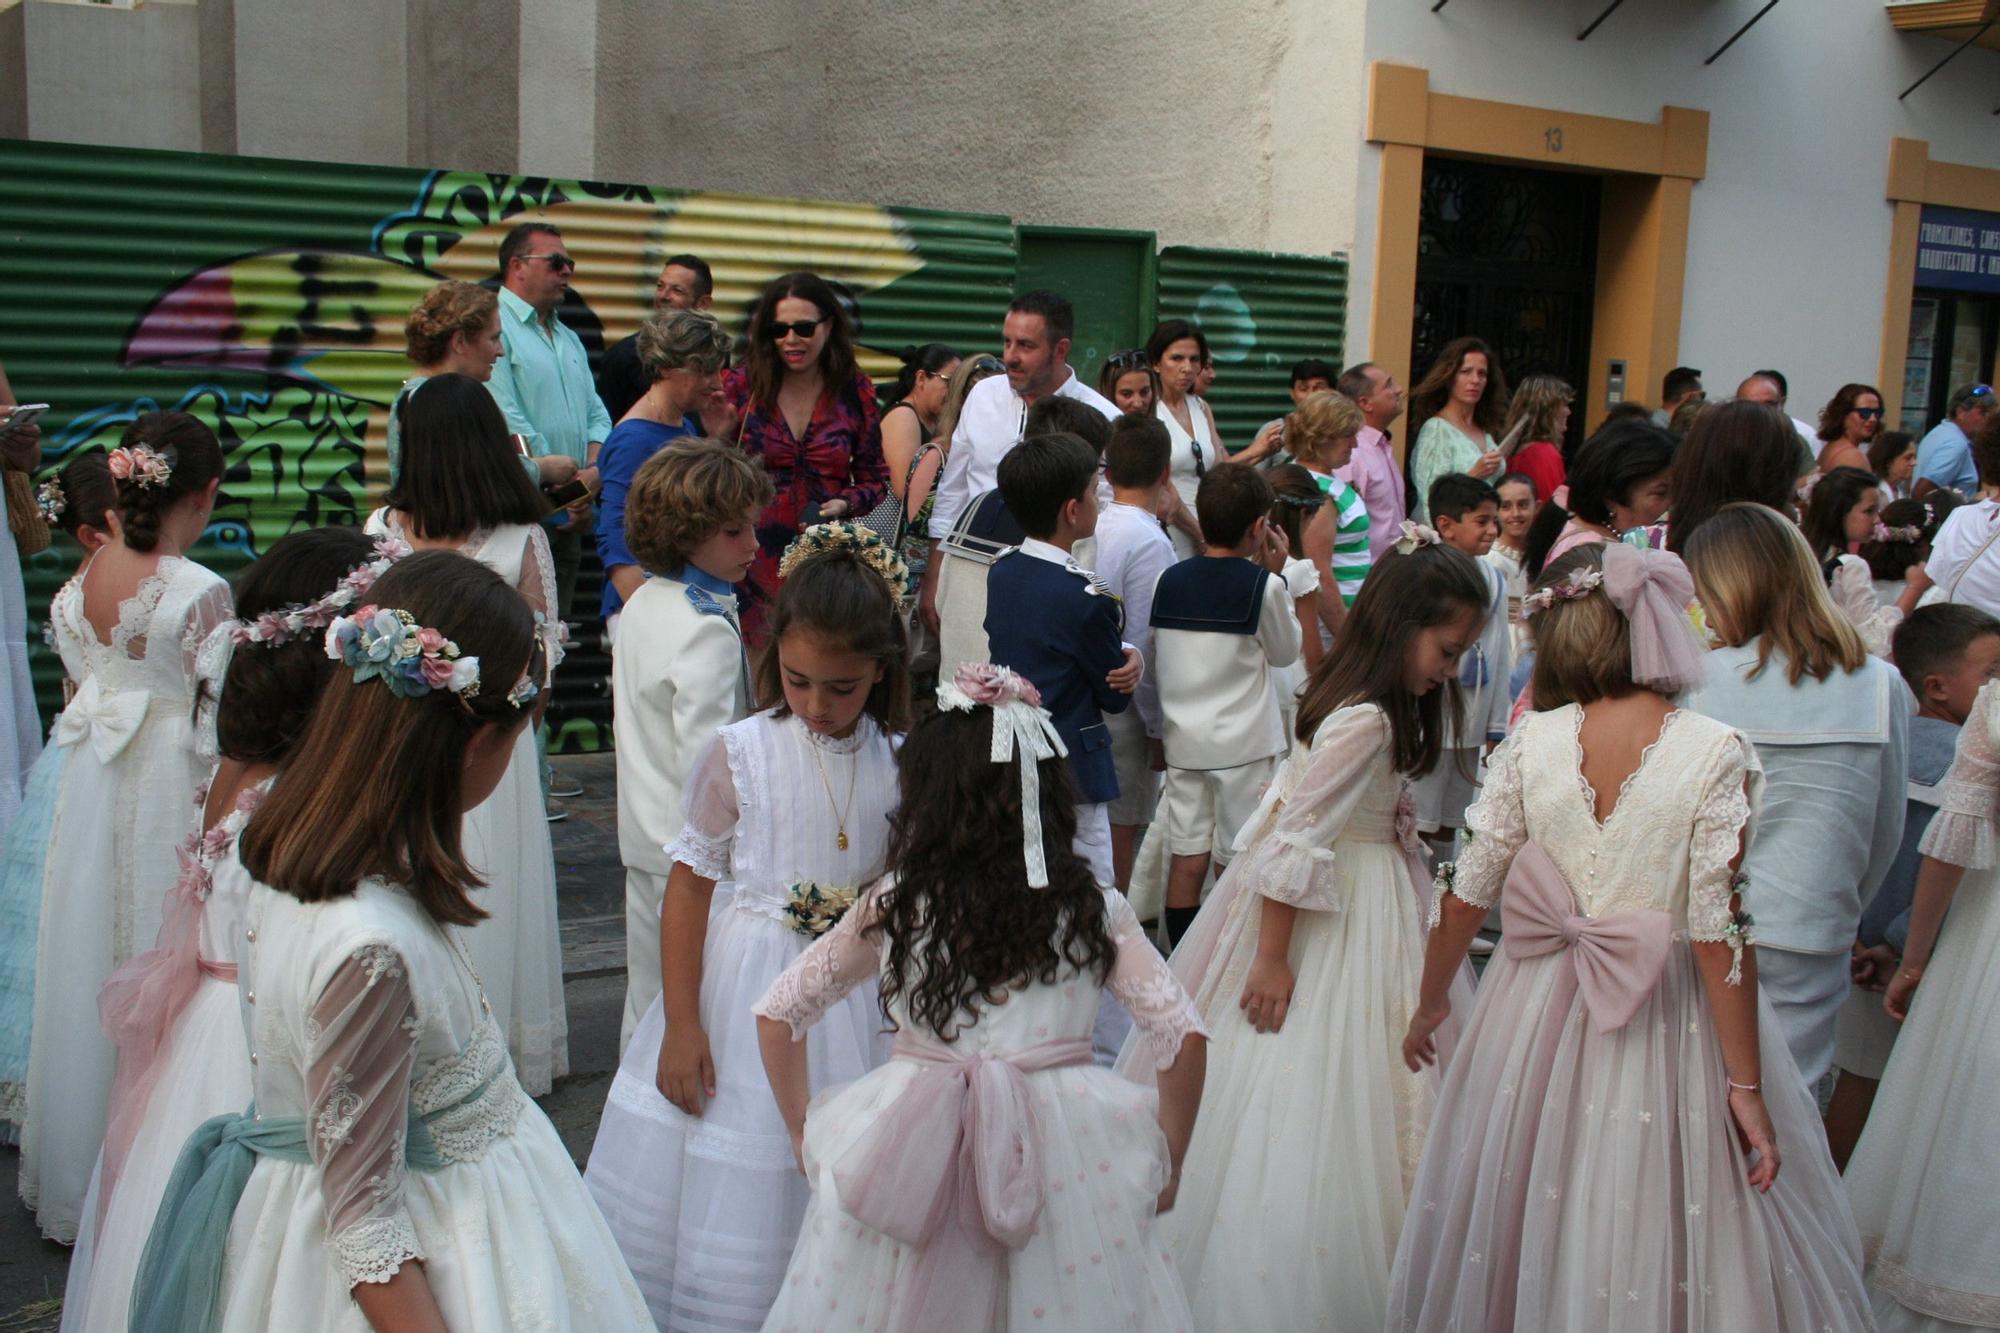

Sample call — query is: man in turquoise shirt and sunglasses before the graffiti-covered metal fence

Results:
[488,222,612,620]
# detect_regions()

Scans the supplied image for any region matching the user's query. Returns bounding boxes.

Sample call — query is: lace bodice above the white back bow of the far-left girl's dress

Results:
[48,556,232,717]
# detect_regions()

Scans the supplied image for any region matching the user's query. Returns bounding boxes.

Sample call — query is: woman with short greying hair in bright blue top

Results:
[598,310,730,638]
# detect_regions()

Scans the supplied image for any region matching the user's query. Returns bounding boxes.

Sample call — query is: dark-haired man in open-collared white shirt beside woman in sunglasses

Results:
[918,292,1118,632]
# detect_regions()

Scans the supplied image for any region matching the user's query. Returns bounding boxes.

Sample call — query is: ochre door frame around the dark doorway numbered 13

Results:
[1368,60,1712,430]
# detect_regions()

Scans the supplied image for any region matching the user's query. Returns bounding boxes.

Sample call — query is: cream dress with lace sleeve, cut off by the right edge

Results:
[1846,685,2000,1333]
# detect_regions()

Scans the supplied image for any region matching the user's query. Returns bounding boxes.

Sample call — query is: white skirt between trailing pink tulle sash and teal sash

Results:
[62,964,252,1333]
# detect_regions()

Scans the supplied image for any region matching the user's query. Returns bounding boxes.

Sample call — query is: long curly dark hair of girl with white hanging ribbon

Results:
[868,709,1116,1041]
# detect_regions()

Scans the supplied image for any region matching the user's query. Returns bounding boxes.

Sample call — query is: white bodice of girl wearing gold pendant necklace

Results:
[668,713,898,911]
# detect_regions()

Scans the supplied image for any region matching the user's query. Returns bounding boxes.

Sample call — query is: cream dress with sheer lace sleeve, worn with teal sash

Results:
[216,881,652,1333]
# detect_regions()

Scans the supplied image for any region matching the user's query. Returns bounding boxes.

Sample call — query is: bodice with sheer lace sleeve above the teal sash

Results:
[236,872,528,1283]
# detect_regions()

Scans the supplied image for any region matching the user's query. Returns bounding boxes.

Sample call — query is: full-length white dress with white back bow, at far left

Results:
[20,556,230,1245]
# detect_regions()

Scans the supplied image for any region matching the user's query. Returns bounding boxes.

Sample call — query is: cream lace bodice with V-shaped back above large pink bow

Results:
[1440,705,1760,941]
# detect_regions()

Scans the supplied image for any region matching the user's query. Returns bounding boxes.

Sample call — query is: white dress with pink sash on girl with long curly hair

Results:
[756,891,1202,1333]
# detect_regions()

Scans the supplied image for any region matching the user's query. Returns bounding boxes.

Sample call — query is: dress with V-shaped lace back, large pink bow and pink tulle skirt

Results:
[1388,705,1872,1333]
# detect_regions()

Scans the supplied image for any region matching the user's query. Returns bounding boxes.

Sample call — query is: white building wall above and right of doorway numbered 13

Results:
[1348,0,2000,418]
